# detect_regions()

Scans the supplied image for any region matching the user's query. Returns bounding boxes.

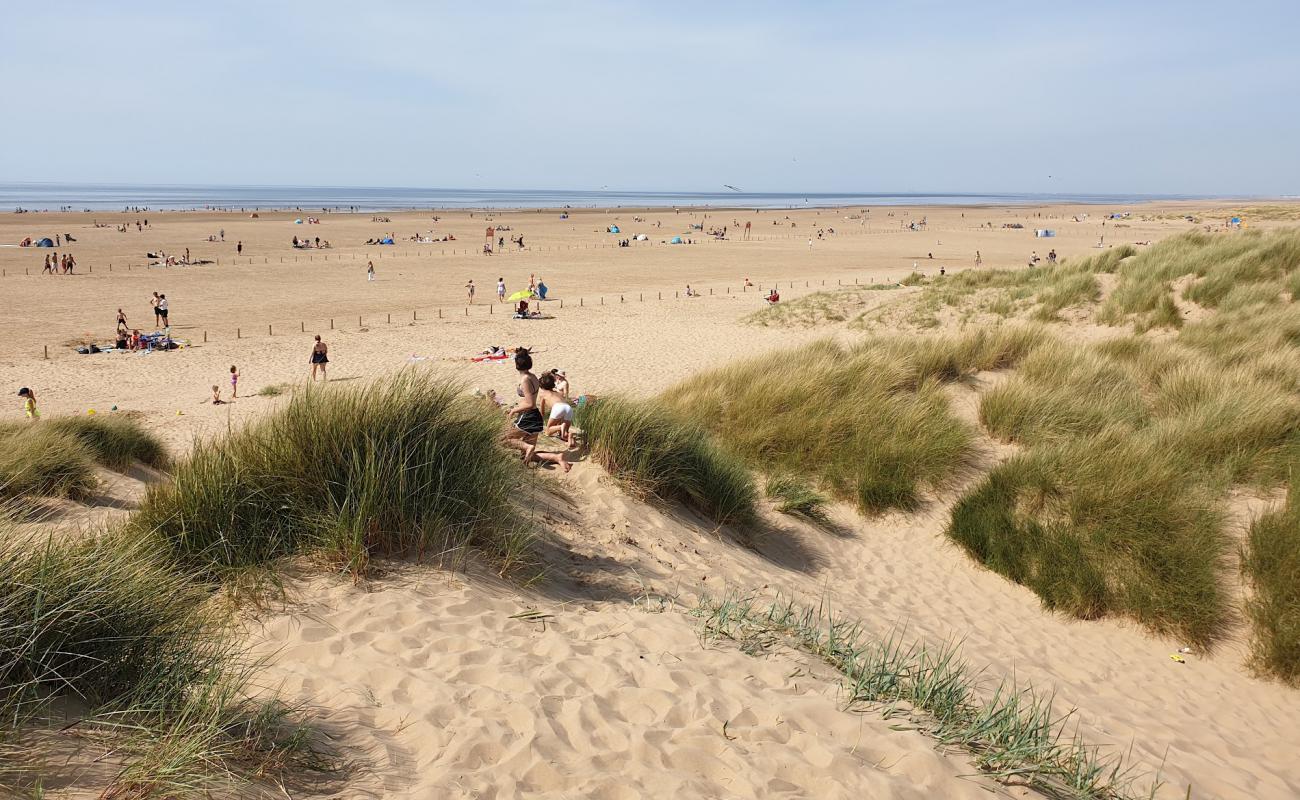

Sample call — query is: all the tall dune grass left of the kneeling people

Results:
[0,372,551,797]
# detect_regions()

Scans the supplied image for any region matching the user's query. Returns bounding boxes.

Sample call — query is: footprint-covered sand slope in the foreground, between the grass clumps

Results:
[244,463,1300,800]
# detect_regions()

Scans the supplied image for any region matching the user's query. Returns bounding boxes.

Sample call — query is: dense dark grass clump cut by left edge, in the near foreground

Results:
[0,531,230,718]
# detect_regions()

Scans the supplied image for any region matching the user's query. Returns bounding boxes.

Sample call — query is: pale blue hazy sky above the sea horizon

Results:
[0,0,1300,195]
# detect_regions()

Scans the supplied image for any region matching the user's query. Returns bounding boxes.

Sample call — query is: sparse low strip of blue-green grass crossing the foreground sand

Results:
[696,596,1160,800]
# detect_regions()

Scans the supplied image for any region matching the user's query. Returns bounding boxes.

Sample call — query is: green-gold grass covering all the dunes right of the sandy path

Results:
[743,229,1300,663]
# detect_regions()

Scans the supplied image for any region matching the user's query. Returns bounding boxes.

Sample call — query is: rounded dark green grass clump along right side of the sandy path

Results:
[946,429,1229,647]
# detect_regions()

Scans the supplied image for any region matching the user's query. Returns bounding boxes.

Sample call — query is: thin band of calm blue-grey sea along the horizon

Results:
[0,183,1183,211]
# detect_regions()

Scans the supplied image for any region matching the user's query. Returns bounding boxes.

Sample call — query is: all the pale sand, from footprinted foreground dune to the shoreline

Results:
[0,200,1300,800]
